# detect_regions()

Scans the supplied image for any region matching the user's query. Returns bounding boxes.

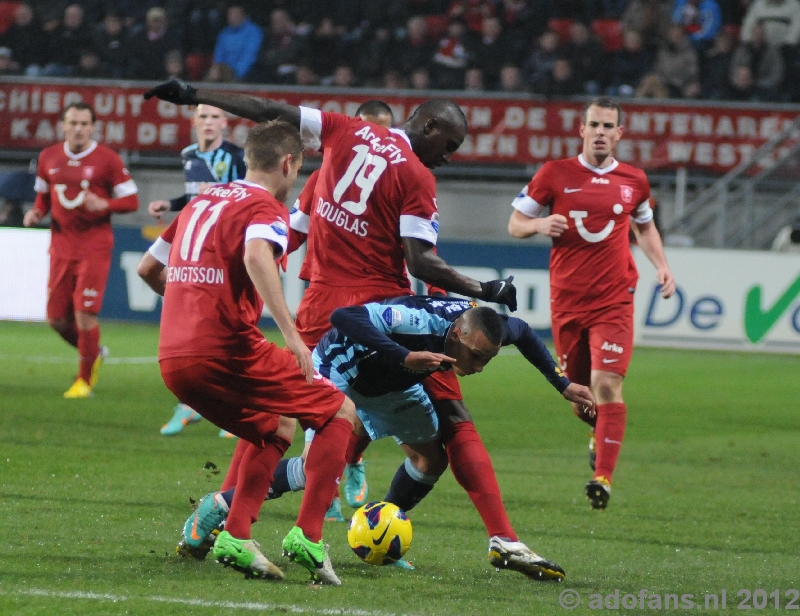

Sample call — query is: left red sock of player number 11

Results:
[225,436,291,539]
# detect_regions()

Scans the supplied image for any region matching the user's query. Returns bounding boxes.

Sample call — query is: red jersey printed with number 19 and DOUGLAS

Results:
[300,107,439,289]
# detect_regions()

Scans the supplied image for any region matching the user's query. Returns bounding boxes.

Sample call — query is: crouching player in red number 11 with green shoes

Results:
[139,122,358,585]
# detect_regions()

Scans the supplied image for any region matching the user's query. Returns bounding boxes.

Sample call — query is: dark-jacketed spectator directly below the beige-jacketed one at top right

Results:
[731,24,785,102]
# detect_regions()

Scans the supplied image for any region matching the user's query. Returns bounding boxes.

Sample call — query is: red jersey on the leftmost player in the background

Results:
[34,141,139,259]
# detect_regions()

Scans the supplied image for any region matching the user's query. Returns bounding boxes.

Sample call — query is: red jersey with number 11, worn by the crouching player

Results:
[150,180,289,359]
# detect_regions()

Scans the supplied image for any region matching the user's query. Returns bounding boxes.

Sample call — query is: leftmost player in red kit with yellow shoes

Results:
[23,103,139,398]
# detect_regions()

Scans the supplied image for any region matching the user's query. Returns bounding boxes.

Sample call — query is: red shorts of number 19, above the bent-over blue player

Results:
[294,282,411,349]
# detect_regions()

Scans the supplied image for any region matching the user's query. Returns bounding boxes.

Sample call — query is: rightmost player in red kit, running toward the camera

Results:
[508,97,675,509]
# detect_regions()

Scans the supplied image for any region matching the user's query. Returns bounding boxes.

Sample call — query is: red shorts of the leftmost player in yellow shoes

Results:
[47,252,111,319]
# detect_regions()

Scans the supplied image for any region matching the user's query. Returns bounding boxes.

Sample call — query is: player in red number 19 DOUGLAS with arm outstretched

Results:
[145,81,564,576]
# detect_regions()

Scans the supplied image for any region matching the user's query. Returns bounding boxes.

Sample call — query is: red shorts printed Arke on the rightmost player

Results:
[551,302,633,386]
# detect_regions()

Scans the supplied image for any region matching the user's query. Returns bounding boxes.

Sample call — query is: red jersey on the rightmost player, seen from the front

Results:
[512,155,653,312]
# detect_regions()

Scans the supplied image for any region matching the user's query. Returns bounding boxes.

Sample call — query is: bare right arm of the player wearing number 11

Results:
[244,238,314,385]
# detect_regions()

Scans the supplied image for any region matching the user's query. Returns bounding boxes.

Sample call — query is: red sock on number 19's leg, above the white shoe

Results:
[445,421,517,541]
